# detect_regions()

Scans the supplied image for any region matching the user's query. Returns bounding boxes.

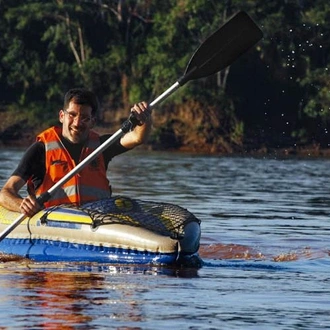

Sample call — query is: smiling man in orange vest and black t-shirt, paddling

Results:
[0,88,151,217]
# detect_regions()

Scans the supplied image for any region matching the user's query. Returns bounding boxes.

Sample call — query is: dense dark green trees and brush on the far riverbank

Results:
[0,0,330,152]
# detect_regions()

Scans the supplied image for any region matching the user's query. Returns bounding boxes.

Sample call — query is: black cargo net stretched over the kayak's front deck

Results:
[78,196,200,239]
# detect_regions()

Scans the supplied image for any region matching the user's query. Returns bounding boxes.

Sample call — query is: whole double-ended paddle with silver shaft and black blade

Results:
[0,11,262,242]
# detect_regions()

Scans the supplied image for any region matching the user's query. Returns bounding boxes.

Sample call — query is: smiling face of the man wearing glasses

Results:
[59,101,94,143]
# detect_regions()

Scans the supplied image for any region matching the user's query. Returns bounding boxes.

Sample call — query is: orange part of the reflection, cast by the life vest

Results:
[17,272,94,329]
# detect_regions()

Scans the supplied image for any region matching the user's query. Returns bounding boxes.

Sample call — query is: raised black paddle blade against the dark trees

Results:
[178,11,263,86]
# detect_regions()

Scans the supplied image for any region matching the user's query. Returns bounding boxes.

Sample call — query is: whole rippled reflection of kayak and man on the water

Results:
[0,262,197,329]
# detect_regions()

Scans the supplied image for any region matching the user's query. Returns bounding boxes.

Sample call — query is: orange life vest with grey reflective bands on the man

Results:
[37,127,111,207]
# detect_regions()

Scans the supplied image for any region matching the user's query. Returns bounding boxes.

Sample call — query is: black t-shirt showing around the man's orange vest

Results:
[12,134,128,187]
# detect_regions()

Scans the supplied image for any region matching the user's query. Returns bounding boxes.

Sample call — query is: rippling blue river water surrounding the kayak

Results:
[0,149,330,329]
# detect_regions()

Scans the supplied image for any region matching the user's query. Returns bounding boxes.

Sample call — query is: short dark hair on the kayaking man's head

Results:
[63,88,99,116]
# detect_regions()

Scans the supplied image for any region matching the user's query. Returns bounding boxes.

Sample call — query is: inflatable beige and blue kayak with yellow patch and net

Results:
[0,196,201,267]
